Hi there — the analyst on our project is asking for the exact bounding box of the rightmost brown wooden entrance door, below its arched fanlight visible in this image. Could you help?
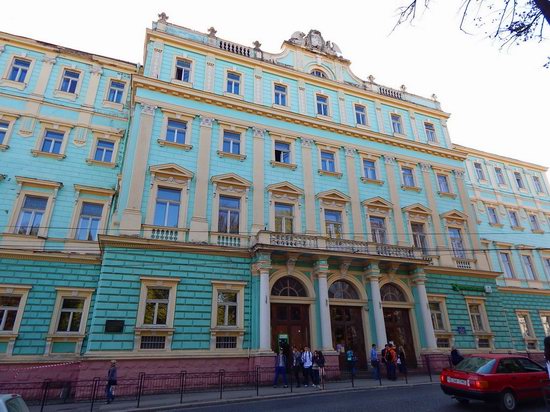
[384,308,416,368]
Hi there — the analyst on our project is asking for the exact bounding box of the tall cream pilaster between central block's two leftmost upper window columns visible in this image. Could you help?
[189,117,214,242]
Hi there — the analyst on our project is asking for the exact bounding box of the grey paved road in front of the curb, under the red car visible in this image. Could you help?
[174,385,546,412]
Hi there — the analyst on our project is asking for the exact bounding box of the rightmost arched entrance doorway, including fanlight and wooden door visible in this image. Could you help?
[380,283,416,368]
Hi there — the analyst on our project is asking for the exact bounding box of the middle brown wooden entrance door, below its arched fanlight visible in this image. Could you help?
[330,305,367,368]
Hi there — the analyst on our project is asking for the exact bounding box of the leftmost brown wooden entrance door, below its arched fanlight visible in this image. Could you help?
[271,303,310,351]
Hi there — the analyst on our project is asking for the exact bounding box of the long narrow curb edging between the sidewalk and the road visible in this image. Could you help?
[119,382,439,412]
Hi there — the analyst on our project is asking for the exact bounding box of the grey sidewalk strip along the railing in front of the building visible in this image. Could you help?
[30,375,439,412]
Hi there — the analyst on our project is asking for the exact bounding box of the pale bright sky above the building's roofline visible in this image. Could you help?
[0,0,550,174]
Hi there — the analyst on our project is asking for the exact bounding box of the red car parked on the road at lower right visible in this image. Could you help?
[440,354,548,411]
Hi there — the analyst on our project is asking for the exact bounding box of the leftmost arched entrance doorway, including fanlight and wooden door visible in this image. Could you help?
[271,276,311,351]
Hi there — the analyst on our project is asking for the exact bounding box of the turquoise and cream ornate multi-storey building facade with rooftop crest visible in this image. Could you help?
[0,15,550,377]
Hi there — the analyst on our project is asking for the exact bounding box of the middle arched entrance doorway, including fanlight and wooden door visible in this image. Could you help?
[328,279,367,369]
